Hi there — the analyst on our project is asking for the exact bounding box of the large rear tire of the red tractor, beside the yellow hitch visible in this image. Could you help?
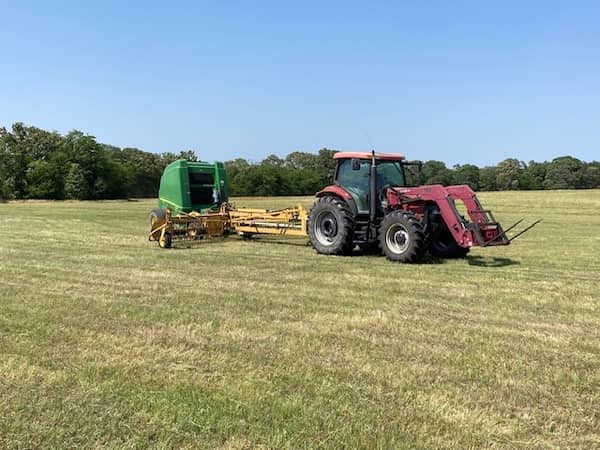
[308,196,354,255]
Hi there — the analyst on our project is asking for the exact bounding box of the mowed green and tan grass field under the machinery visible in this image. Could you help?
[0,190,600,449]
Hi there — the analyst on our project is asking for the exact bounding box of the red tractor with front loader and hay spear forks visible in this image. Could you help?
[308,151,537,262]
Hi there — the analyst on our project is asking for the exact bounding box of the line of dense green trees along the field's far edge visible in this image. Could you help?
[0,123,600,200]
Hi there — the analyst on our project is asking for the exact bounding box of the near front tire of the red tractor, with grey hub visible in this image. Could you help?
[379,210,425,263]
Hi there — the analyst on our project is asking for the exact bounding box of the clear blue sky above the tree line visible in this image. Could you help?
[0,0,600,166]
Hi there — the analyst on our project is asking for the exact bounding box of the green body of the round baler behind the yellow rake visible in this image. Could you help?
[158,159,228,215]
